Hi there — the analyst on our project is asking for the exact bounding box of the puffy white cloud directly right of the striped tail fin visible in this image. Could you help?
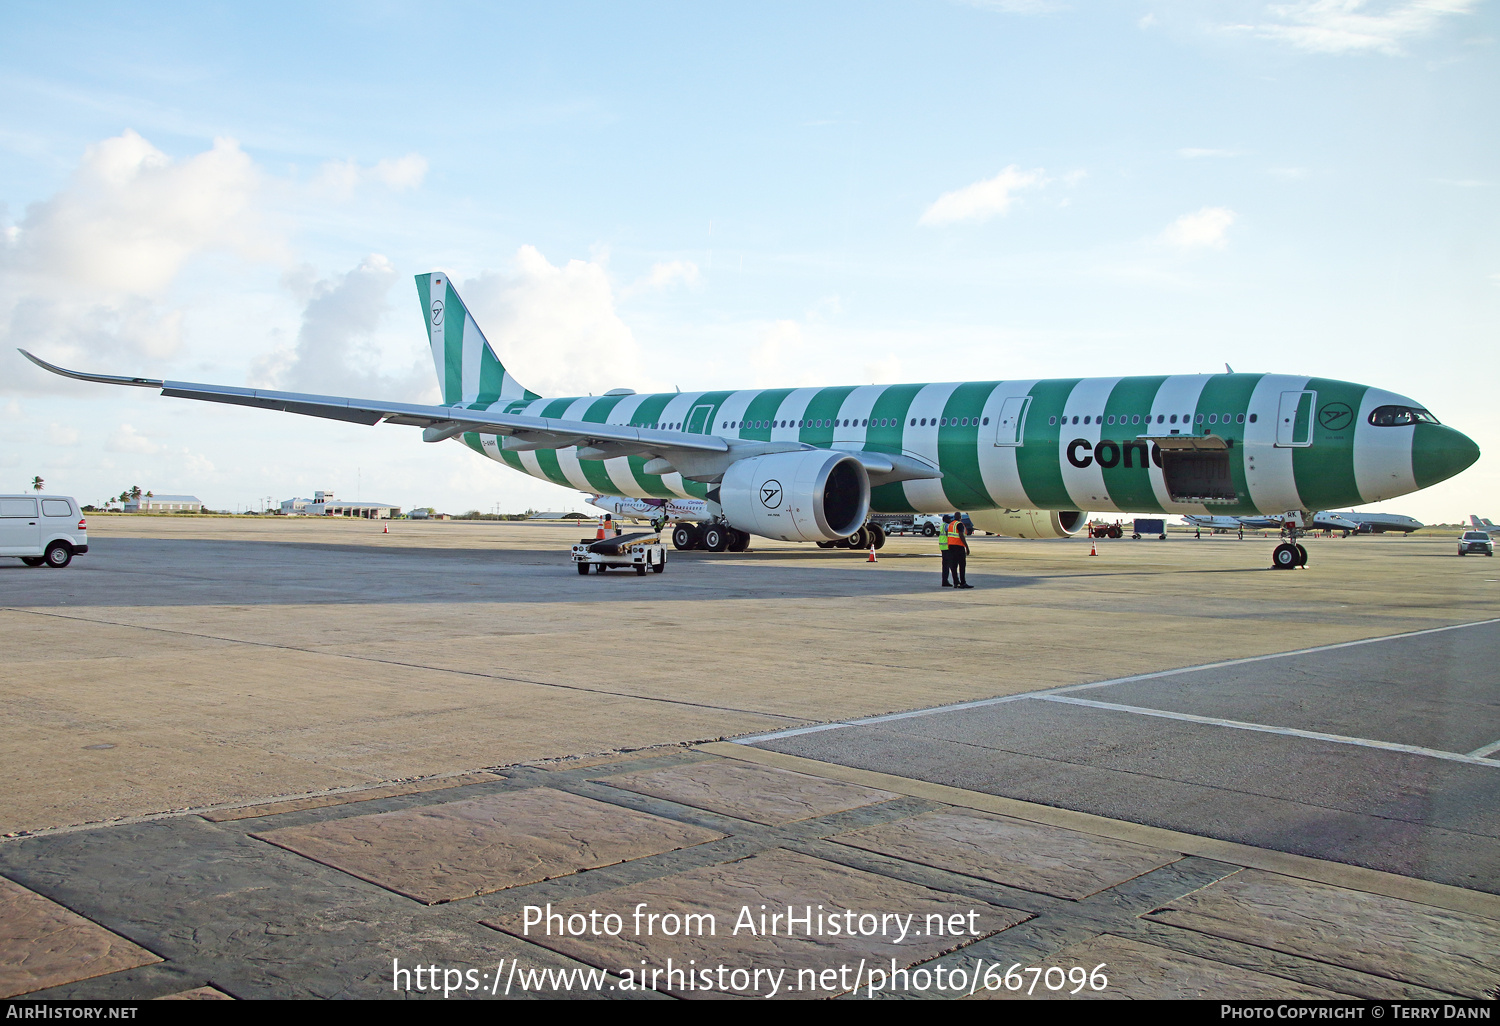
[459,246,657,396]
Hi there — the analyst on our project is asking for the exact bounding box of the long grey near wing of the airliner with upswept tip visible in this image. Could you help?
[20,350,729,459]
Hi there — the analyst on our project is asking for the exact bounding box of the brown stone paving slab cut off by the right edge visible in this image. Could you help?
[1146,870,1500,998]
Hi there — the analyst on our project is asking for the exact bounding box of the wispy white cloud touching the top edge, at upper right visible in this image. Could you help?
[1236,0,1478,54]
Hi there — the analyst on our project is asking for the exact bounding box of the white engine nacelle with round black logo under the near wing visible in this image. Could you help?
[719,449,870,542]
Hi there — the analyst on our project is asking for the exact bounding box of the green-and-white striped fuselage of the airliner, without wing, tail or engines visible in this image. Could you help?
[462,374,1452,515]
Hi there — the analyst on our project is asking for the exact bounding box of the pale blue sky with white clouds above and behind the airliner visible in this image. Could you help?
[0,0,1500,521]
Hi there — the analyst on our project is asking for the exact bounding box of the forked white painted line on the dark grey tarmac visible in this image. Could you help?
[732,617,1500,767]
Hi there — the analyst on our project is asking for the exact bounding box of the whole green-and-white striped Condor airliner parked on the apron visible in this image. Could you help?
[23,273,1479,569]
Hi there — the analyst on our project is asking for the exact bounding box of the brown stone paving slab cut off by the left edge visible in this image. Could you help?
[0,878,161,998]
